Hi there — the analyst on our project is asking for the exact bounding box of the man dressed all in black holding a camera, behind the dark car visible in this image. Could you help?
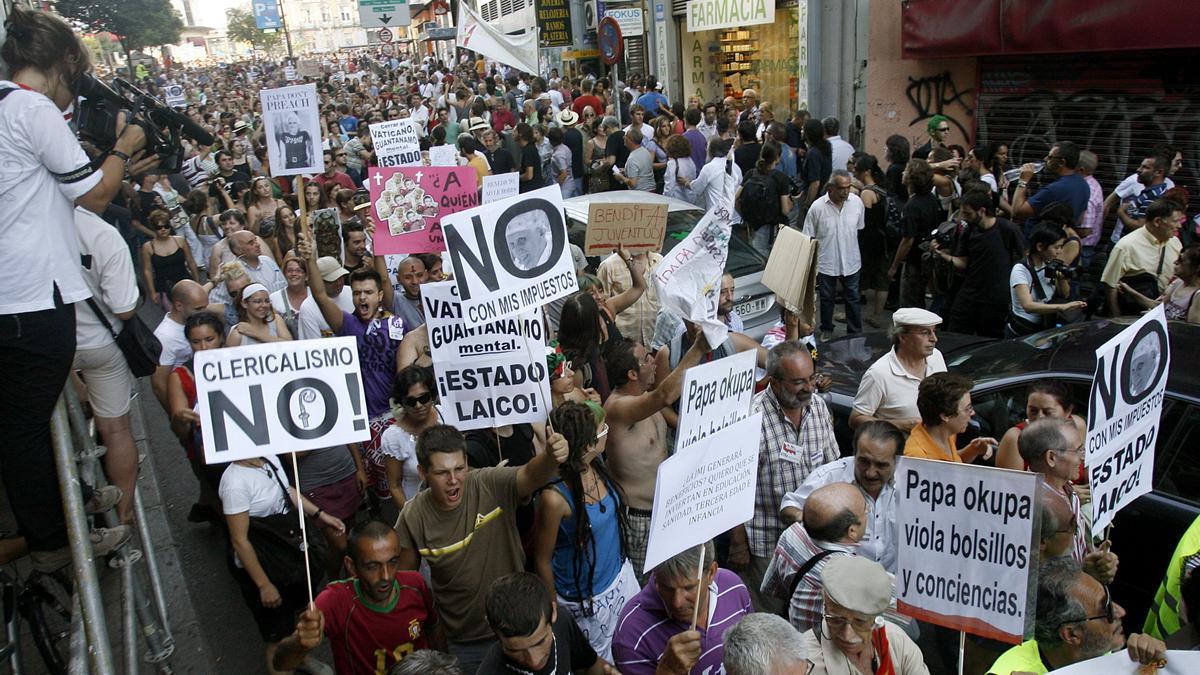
[929,190,1025,338]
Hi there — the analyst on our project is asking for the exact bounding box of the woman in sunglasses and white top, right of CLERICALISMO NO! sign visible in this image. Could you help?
[379,365,442,522]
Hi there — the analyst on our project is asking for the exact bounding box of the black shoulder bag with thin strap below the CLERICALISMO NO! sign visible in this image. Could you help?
[246,462,329,589]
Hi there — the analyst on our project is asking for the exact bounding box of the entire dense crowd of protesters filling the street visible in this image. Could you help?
[0,6,1200,675]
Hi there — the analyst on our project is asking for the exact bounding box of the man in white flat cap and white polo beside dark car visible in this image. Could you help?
[850,307,946,432]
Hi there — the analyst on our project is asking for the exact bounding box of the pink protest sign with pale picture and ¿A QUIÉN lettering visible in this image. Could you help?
[367,167,479,253]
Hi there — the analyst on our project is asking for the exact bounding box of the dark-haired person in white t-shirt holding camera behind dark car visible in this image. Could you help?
[1004,223,1087,338]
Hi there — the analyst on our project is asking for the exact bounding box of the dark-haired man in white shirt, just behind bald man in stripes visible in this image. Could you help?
[779,422,905,574]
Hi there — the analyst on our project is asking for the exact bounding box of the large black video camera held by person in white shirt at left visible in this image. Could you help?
[74,73,214,173]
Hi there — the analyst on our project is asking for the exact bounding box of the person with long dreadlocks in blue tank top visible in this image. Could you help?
[534,402,638,661]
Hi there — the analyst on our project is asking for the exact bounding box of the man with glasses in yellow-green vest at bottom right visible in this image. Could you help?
[988,556,1166,675]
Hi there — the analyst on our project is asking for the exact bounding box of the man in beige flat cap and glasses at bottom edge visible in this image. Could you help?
[800,556,929,675]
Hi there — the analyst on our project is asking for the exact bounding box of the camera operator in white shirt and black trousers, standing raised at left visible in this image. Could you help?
[0,6,158,571]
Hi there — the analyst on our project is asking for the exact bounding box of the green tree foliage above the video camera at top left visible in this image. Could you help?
[54,0,184,53]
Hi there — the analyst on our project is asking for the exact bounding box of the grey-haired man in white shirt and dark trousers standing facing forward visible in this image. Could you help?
[804,169,866,342]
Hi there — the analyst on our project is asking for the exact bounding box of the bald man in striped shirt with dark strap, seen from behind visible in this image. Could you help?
[762,483,866,633]
